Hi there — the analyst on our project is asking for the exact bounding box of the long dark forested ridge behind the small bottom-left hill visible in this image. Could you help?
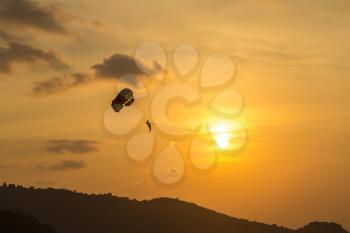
[0,185,348,233]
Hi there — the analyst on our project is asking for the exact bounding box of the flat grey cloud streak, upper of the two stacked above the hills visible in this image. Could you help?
[45,139,99,154]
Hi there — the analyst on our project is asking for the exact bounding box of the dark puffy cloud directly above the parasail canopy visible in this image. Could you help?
[91,54,162,85]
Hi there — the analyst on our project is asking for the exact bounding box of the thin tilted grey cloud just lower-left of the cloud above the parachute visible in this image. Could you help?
[32,73,91,96]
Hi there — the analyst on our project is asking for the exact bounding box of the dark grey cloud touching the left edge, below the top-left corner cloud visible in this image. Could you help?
[0,42,68,73]
